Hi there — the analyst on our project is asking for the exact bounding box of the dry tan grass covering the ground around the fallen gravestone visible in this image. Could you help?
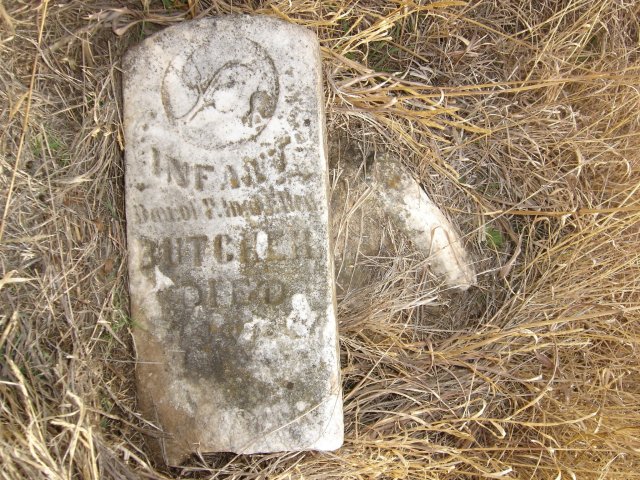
[0,0,640,479]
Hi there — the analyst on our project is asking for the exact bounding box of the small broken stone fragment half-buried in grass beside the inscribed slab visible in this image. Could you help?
[331,148,476,292]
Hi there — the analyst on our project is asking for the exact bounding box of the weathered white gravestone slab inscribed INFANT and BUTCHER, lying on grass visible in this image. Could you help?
[124,16,343,464]
